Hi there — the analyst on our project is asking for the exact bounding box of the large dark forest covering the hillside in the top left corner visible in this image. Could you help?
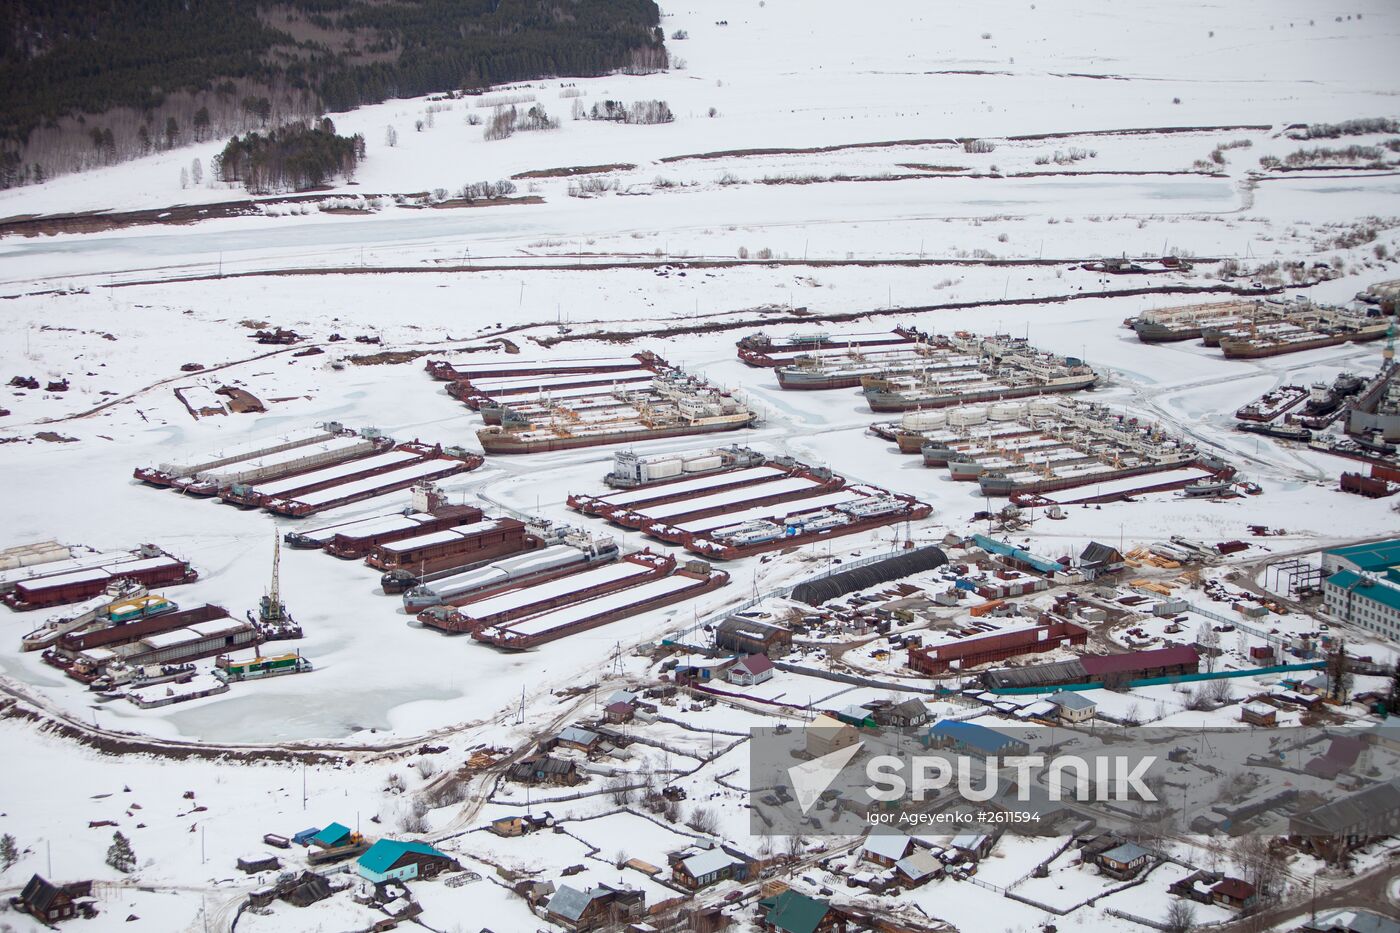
[0,0,665,186]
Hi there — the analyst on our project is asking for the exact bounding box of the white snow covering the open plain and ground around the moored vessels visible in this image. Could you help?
[0,0,1400,930]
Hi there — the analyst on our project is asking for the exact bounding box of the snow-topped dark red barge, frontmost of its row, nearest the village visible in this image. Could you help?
[472,562,729,651]
